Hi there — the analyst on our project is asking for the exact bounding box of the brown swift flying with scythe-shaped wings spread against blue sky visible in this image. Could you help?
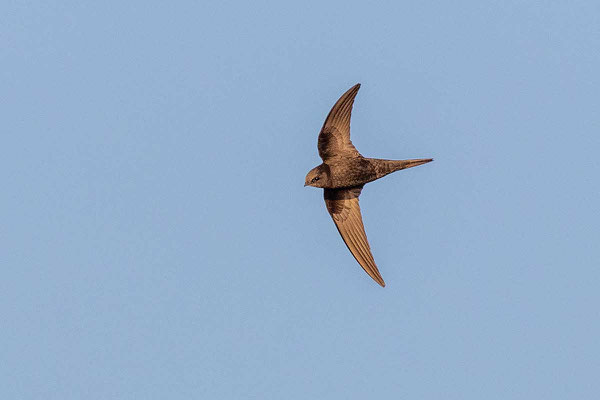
[304,83,433,286]
